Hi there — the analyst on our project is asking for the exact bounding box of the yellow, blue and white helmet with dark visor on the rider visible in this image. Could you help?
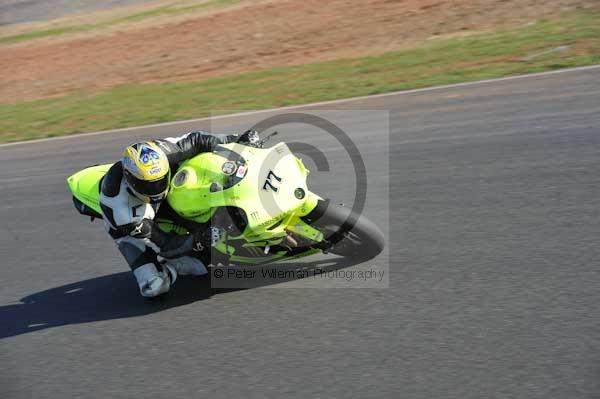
[121,141,171,203]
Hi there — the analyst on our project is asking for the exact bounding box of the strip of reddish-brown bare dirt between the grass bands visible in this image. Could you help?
[0,0,598,103]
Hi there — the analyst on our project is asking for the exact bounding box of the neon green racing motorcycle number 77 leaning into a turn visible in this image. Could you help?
[67,133,385,265]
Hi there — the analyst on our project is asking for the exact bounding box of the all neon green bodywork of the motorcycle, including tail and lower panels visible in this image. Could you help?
[67,143,323,264]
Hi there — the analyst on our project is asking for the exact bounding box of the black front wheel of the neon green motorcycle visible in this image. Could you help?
[302,200,385,260]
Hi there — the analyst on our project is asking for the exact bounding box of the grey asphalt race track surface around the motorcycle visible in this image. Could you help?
[0,69,600,398]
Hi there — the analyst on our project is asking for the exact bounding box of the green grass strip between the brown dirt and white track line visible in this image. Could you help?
[0,10,600,142]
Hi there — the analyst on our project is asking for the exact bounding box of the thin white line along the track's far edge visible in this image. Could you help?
[0,65,600,148]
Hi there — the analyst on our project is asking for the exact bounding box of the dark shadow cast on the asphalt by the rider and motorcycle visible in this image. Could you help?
[0,258,357,339]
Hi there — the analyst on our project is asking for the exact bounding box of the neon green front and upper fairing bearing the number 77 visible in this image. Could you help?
[167,143,316,241]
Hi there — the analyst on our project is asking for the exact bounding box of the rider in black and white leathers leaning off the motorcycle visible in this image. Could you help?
[100,130,258,298]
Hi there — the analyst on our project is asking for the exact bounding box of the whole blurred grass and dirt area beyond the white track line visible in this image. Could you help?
[0,0,600,142]
